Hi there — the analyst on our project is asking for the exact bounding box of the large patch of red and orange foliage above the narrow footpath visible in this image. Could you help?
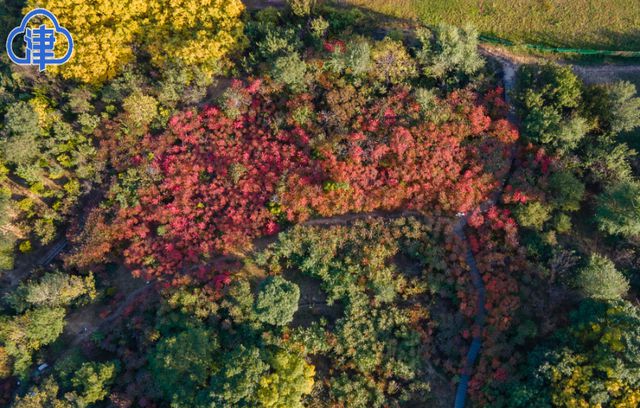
[75,82,518,284]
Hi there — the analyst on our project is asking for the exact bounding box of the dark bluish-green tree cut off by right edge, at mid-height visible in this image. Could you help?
[595,181,640,237]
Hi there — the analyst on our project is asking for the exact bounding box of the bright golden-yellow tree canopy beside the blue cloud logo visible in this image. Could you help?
[25,0,244,84]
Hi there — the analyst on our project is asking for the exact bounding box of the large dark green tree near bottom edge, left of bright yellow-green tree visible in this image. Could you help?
[149,328,218,407]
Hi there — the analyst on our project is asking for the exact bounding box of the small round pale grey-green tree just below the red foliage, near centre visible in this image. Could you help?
[255,276,300,326]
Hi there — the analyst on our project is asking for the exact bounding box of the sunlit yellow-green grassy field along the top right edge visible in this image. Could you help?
[341,0,640,51]
